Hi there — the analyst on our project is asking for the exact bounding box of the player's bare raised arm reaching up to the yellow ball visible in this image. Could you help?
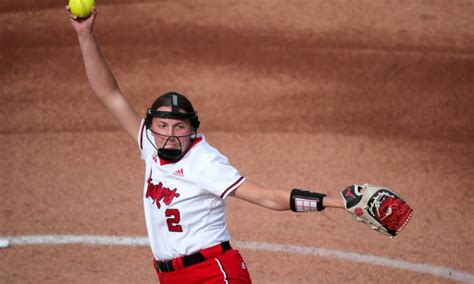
[66,7,141,139]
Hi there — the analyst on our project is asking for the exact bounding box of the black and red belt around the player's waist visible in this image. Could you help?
[153,241,232,272]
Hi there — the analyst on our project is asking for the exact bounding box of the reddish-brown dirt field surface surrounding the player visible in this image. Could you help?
[0,0,474,283]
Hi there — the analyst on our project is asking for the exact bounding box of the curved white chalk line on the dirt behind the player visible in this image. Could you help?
[0,235,474,283]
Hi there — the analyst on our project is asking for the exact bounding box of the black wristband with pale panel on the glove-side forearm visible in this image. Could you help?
[290,188,326,212]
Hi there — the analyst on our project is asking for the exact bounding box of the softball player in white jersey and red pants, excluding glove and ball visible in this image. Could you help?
[70,9,345,283]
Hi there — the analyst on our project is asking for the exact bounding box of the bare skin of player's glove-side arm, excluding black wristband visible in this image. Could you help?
[231,180,345,211]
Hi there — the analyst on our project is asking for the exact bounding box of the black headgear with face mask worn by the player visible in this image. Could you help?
[145,92,200,162]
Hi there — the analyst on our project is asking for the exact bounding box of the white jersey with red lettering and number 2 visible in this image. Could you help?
[138,118,245,260]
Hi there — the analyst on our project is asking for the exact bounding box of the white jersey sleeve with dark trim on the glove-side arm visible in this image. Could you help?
[199,153,245,199]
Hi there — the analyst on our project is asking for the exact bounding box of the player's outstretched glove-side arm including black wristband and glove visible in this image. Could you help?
[231,180,413,237]
